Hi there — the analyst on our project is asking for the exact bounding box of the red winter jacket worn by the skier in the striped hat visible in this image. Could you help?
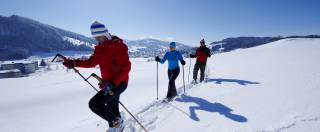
[77,37,131,86]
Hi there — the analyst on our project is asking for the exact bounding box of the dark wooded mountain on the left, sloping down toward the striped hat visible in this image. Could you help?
[0,15,95,60]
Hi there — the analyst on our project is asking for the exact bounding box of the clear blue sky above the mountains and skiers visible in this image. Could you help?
[0,0,320,45]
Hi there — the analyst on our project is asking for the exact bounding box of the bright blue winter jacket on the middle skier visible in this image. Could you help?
[160,50,183,70]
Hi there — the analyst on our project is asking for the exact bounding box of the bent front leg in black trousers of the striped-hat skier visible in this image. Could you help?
[89,90,116,126]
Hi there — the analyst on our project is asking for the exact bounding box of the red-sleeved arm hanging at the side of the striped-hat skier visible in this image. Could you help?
[113,44,131,86]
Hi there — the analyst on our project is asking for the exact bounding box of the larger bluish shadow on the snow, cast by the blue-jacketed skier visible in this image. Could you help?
[175,94,248,122]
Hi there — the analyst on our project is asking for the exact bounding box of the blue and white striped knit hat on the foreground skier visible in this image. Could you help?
[90,21,112,40]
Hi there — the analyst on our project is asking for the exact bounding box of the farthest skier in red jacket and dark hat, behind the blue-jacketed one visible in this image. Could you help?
[190,39,211,83]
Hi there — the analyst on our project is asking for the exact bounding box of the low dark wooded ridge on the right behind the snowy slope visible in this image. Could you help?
[209,35,320,52]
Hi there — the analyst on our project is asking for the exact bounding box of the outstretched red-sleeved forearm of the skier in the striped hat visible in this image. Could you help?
[75,49,100,68]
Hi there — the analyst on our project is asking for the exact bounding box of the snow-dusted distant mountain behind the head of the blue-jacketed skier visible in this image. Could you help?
[126,39,191,57]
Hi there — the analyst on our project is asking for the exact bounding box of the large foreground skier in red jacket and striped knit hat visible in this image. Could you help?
[64,22,131,132]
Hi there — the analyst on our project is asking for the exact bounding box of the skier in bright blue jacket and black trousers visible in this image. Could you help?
[155,42,186,101]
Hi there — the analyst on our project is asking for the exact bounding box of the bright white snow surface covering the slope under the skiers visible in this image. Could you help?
[0,39,320,132]
